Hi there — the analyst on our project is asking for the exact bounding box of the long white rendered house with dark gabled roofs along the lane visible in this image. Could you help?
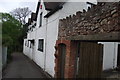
[23,0,92,76]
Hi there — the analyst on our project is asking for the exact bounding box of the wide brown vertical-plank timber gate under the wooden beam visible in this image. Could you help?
[78,42,103,78]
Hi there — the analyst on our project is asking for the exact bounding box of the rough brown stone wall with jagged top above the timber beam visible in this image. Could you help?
[58,2,120,40]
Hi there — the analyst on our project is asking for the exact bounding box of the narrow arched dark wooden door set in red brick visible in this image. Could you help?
[58,44,66,78]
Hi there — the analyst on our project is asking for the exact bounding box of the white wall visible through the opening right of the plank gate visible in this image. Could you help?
[100,42,119,70]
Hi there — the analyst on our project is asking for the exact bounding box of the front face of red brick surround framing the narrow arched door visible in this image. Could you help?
[54,40,71,78]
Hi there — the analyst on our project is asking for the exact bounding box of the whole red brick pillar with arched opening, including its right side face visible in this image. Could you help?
[55,40,76,78]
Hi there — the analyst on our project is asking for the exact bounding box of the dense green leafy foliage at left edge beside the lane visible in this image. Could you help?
[0,13,23,53]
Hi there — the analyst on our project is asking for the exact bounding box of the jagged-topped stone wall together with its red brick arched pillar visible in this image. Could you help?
[55,2,120,78]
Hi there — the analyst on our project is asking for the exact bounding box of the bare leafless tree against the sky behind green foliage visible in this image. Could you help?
[10,7,31,24]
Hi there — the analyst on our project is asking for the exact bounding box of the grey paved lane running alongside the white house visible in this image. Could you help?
[3,53,46,78]
